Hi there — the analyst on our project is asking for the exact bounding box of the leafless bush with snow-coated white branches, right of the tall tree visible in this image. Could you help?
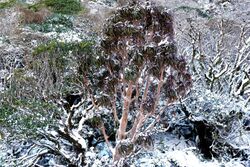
[177,9,250,99]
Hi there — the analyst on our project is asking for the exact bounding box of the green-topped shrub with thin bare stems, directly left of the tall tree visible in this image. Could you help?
[29,41,94,96]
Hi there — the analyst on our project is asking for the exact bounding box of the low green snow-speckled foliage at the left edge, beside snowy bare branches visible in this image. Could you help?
[0,98,59,138]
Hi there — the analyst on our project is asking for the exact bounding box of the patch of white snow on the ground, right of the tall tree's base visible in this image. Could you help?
[133,133,248,167]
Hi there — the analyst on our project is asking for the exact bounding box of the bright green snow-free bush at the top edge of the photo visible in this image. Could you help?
[44,0,82,15]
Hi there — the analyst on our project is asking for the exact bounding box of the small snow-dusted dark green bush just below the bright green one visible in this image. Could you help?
[29,14,73,33]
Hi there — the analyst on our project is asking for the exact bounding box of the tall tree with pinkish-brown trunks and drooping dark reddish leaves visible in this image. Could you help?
[92,2,191,161]
